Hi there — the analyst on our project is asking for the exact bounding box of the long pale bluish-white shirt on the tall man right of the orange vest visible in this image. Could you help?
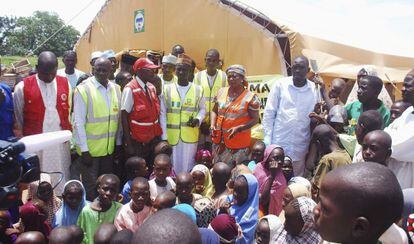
[262,76,318,161]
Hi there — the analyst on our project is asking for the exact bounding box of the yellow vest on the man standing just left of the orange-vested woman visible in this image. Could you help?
[194,69,228,120]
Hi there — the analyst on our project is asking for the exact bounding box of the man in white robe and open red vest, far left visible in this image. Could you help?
[13,52,72,195]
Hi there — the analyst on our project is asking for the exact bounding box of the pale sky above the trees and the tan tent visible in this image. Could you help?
[0,0,414,57]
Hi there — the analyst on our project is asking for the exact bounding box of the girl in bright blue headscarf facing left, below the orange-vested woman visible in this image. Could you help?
[227,174,259,243]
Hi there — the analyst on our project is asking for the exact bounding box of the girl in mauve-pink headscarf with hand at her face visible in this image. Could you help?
[254,145,286,215]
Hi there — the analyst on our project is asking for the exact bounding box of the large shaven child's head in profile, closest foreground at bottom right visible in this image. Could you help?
[314,162,403,244]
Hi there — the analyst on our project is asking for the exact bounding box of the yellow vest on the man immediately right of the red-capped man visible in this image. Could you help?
[164,83,203,146]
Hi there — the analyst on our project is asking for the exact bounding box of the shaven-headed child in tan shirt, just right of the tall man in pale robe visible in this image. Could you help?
[312,124,352,188]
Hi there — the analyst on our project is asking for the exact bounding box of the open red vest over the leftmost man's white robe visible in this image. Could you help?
[23,75,72,136]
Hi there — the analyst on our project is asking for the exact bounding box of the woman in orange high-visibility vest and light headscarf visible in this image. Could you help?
[210,64,260,168]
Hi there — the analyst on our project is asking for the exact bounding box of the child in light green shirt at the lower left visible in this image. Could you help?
[77,174,122,244]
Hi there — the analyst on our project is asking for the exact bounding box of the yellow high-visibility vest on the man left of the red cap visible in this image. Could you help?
[75,77,121,157]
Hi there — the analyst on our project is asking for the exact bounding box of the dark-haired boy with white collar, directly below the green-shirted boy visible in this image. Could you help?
[352,110,383,163]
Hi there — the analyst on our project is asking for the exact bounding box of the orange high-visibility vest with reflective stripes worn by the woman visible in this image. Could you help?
[212,87,254,149]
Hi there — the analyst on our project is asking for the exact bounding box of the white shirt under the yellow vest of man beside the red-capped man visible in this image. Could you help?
[160,83,206,140]
